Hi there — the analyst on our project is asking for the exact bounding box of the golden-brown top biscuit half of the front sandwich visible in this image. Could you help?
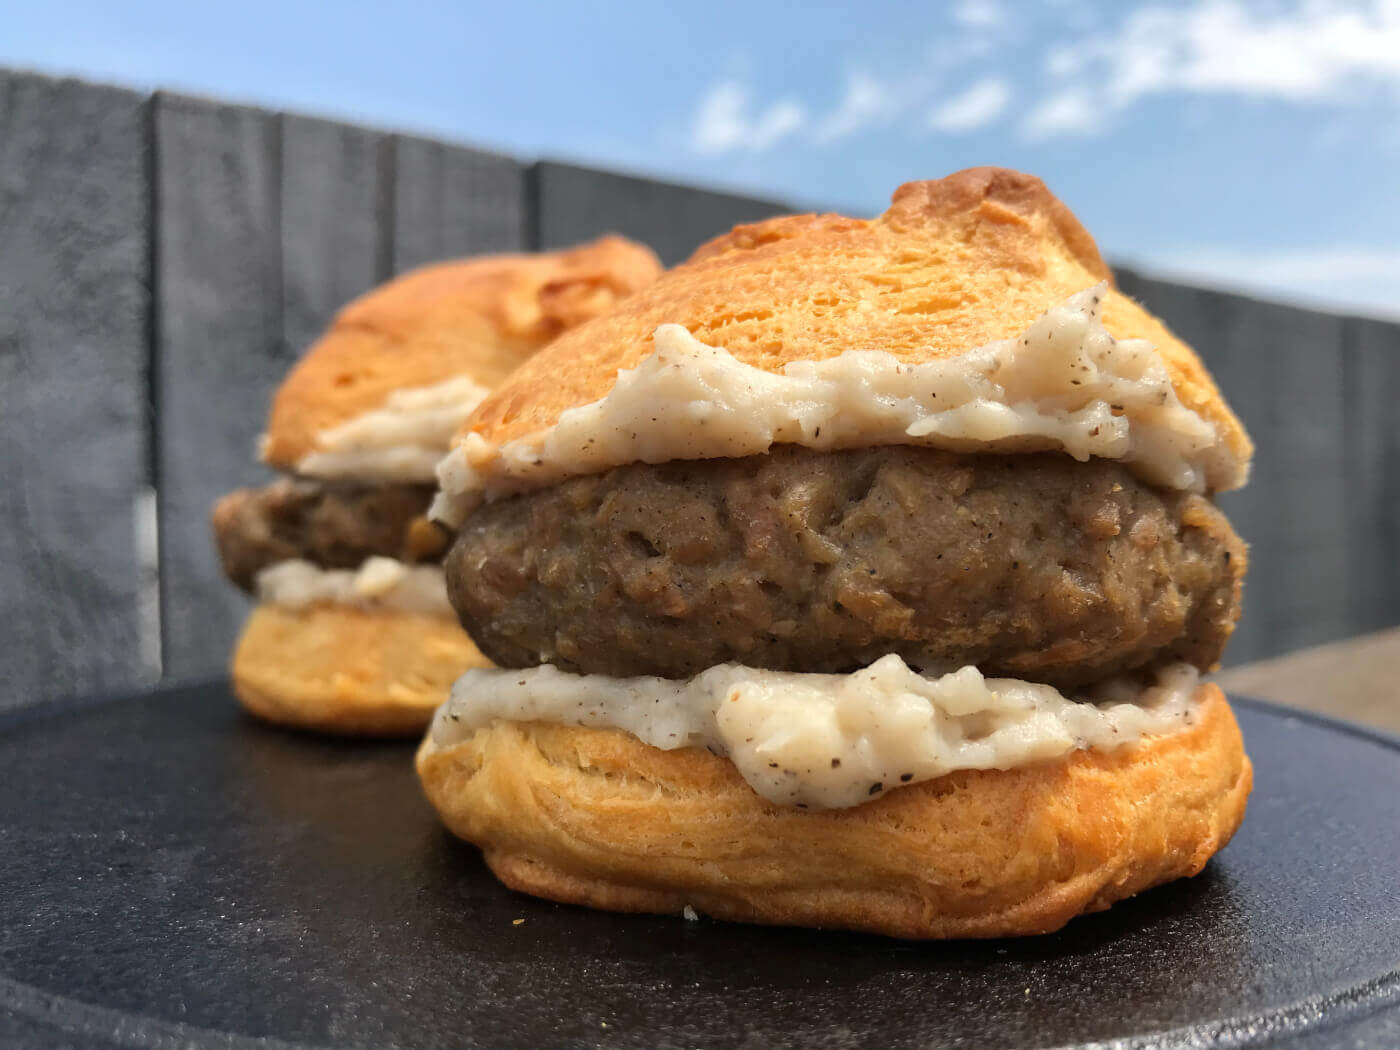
[469,168,1253,462]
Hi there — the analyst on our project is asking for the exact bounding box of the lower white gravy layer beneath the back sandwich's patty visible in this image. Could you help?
[256,557,456,619]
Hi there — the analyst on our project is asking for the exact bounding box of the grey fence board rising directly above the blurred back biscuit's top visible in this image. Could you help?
[391,136,526,273]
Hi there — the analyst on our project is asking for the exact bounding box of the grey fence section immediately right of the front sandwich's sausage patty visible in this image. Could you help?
[1119,272,1349,664]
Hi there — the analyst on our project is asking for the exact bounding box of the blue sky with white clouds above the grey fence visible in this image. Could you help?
[0,0,1400,316]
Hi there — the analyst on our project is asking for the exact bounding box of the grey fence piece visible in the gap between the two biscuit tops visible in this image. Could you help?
[531,161,792,266]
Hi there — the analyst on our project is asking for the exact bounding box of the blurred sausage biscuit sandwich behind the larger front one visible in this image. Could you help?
[213,237,661,735]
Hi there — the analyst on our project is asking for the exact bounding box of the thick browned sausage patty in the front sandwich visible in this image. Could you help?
[447,447,1245,686]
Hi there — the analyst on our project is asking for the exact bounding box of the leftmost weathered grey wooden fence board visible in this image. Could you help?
[0,70,151,710]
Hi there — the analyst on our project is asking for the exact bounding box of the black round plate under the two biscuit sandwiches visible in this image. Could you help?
[0,683,1400,1047]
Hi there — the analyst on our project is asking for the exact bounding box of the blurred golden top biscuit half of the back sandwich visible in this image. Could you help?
[263,237,661,469]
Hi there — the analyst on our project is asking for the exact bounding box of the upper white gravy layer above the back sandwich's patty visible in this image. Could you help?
[297,375,490,482]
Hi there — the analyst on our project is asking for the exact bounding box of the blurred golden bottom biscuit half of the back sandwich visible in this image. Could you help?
[232,602,490,736]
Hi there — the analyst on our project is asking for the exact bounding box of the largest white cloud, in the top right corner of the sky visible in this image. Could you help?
[1022,0,1400,139]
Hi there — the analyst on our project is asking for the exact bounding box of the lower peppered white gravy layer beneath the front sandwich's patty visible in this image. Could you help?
[430,654,1198,809]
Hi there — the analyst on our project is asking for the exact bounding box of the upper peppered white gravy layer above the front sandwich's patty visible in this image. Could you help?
[431,284,1246,526]
